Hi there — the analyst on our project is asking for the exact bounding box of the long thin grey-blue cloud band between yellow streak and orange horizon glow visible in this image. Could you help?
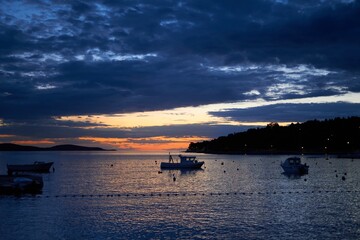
[1,121,247,140]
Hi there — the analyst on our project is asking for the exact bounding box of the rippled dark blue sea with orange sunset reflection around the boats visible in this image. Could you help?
[0,152,360,240]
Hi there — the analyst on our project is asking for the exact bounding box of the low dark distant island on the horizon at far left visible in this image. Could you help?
[0,143,113,151]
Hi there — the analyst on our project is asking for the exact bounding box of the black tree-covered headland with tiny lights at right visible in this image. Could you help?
[186,117,360,156]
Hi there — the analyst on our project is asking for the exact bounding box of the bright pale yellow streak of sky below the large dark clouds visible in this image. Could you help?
[57,92,360,130]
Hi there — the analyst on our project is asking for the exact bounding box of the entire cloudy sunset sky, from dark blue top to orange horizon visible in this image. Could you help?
[0,0,360,152]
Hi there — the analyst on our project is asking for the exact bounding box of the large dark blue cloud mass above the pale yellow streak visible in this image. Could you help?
[0,0,360,140]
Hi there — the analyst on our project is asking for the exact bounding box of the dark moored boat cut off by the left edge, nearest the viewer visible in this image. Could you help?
[0,175,43,194]
